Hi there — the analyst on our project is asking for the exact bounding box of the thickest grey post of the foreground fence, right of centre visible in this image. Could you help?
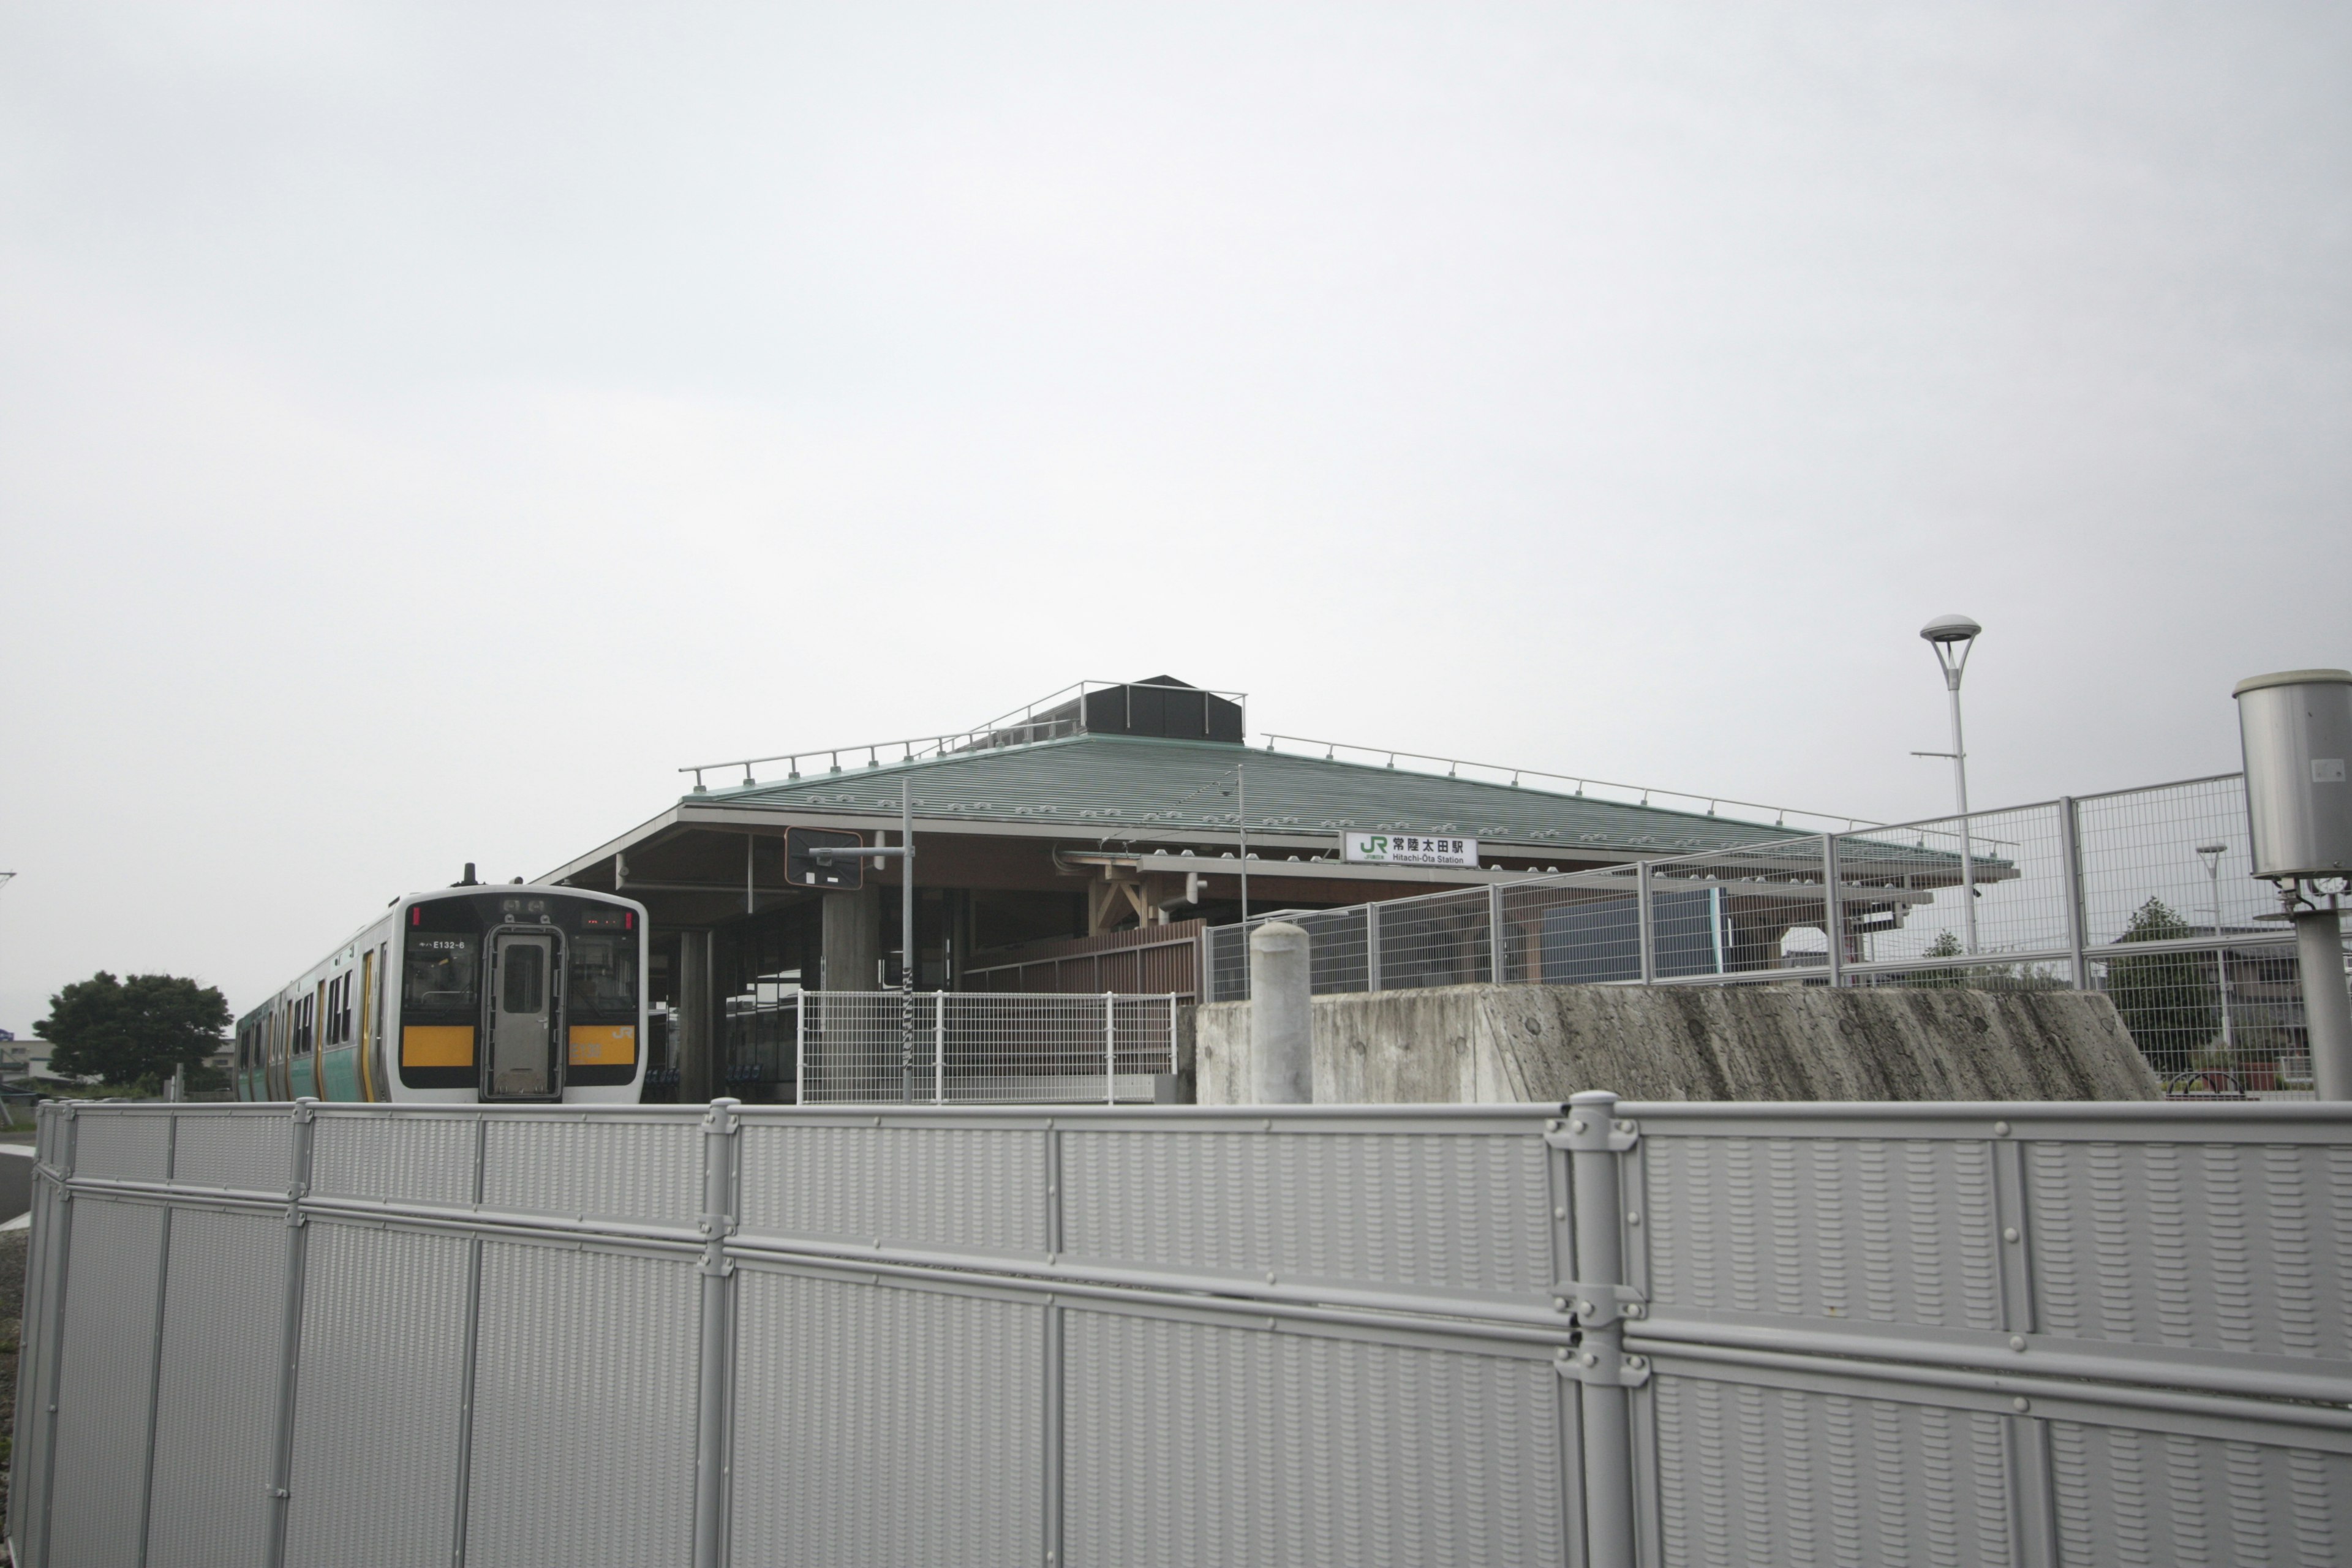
[1566,1090,1649,1568]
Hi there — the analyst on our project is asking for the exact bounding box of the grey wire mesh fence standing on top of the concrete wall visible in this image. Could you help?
[1207,774,2345,1096]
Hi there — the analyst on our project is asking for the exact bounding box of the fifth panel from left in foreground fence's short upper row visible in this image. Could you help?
[736,1107,1051,1260]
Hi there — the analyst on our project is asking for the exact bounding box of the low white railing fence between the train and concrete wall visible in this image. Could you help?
[727,992,1178,1105]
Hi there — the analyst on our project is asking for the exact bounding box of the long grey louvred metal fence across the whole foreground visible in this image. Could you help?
[9,1096,2352,1568]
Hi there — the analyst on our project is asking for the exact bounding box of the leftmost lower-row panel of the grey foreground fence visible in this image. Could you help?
[47,1194,165,1568]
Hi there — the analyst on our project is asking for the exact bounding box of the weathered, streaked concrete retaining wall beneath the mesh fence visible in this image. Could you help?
[1193,985,2159,1105]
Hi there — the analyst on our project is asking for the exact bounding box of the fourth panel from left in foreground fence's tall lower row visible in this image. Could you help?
[466,1242,698,1568]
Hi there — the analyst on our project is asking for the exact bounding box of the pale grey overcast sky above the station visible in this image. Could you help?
[0,0,2352,1032]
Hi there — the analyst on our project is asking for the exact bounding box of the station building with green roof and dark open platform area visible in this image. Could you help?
[541,675,1882,1098]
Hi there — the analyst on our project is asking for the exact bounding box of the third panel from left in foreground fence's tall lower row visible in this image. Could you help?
[279,1222,475,1568]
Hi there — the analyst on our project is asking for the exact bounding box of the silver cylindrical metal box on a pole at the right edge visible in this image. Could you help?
[2232,670,2352,881]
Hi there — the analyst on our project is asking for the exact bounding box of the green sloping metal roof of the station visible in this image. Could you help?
[687,733,1957,870]
